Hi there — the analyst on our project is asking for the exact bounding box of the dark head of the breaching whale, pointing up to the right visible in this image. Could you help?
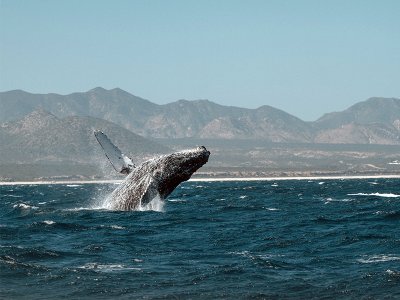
[157,146,210,198]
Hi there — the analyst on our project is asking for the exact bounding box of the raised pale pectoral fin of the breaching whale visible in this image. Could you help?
[94,130,135,174]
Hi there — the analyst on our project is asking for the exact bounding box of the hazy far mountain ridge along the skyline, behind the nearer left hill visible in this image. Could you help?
[0,88,400,144]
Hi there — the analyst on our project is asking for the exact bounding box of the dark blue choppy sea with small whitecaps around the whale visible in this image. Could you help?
[0,179,400,299]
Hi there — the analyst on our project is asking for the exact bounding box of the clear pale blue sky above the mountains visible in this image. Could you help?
[0,0,400,120]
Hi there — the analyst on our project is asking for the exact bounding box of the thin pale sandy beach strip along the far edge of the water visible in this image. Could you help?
[0,174,400,186]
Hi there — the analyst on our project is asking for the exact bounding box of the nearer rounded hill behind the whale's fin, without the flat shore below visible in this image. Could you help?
[0,109,171,164]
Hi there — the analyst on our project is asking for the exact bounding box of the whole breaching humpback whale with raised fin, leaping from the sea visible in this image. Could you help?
[95,131,210,210]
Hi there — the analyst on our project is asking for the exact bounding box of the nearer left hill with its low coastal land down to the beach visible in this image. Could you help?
[0,109,172,180]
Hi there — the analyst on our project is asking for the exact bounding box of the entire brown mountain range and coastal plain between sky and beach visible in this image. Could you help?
[0,88,400,181]
